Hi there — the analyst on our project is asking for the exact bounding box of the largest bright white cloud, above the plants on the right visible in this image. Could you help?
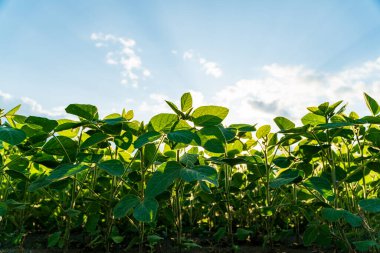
[212,58,380,124]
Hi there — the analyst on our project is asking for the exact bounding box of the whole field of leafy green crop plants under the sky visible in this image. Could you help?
[0,93,380,252]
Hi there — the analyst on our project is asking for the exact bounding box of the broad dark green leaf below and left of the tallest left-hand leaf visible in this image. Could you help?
[42,136,78,161]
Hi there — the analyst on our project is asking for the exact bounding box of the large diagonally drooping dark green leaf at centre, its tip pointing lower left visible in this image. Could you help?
[145,161,182,198]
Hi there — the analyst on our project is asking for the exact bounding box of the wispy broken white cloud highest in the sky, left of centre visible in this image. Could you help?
[91,33,151,87]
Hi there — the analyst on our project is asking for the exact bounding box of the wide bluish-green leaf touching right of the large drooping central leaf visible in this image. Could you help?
[180,165,218,186]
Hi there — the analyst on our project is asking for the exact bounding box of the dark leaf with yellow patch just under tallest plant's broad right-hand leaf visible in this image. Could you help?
[197,126,225,153]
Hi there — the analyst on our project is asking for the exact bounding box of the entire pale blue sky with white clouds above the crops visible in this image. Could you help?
[0,0,380,123]
